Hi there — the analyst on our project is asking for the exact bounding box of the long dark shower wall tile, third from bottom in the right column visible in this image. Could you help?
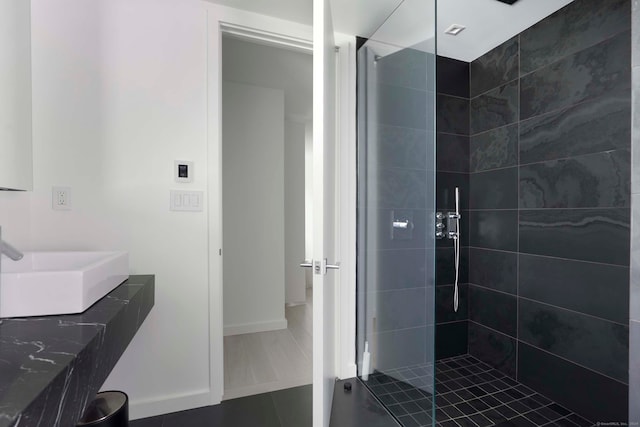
[516,252,629,323]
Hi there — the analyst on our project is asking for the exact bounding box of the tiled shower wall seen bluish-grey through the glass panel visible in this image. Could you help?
[358,49,436,371]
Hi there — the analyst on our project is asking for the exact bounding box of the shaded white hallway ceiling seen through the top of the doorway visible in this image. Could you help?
[222,36,313,123]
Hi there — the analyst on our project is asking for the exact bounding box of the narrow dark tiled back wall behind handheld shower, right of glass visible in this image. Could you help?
[436,56,470,359]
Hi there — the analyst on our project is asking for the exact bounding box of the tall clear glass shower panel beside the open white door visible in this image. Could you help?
[357,0,436,426]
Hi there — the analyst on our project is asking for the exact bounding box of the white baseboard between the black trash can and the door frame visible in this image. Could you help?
[129,390,211,420]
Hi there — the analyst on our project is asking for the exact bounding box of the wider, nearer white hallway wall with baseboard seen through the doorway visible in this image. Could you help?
[222,82,287,335]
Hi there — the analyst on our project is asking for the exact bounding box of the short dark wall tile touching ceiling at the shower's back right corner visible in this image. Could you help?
[470,37,519,97]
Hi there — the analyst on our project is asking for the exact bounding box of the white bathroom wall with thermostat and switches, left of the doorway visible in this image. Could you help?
[30,0,210,418]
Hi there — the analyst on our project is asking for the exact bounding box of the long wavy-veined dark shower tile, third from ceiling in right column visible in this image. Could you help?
[520,93,631,166]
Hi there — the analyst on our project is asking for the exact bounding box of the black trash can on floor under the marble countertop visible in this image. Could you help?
[76,391,129,427]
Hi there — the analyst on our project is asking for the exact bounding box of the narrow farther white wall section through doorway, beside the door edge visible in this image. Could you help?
[284,120,307,303]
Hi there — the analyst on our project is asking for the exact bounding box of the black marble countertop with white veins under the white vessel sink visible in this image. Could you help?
[0,276,155,427]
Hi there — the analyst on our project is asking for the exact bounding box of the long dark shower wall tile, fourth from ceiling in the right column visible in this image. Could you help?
[520,150,631,209]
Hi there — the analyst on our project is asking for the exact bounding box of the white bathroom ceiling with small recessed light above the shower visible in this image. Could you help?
[208,0,573,61]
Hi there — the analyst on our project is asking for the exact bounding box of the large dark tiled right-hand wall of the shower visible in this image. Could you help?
[462,0,640,422]
